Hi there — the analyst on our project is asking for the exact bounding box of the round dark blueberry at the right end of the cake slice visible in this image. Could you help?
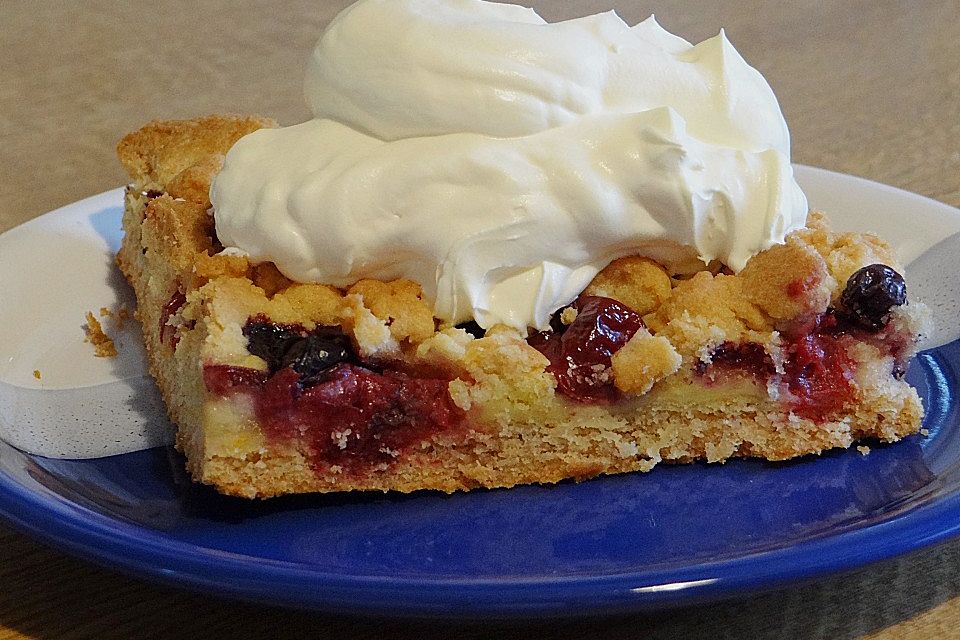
[840,264,907,331]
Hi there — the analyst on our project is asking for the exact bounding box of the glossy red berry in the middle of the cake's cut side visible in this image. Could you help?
[528,296,644,402]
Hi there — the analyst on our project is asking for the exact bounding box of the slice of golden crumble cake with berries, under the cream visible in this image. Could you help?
[118,116,924,497]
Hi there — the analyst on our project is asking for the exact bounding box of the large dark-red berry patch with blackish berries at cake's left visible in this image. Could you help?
[203,318,464,473]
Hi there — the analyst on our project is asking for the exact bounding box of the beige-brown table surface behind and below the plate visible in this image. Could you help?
[0,0,960,640]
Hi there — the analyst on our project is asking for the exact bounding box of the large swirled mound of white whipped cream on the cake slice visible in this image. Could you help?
[211,0,807,329]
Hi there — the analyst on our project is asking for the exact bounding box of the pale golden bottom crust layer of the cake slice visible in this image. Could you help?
[191,389,922,498]
